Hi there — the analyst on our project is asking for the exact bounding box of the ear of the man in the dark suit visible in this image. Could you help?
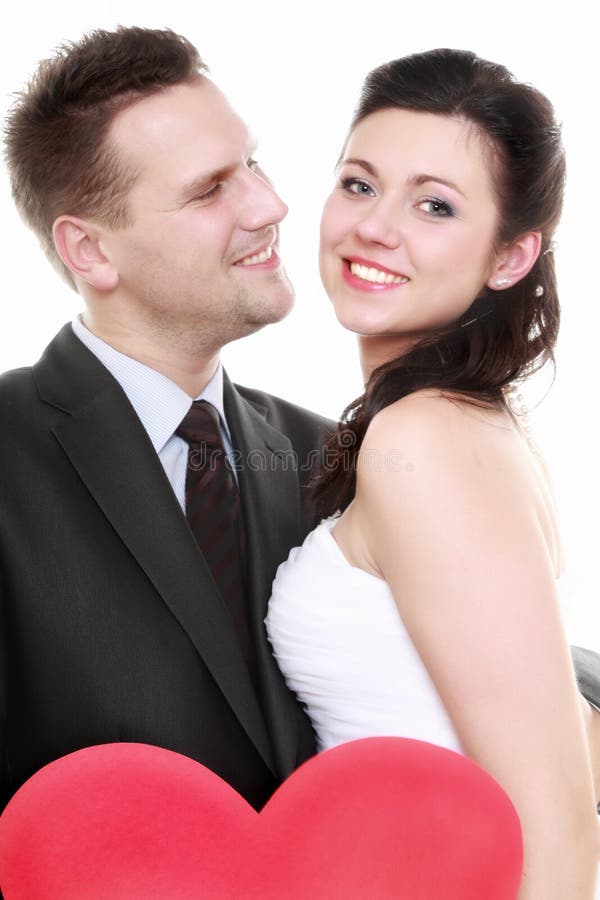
[52,216,119,291]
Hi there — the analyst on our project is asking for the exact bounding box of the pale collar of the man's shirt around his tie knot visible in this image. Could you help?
[71,317,231,453]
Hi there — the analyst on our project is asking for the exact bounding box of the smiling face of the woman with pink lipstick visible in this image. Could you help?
[320,109,498,355]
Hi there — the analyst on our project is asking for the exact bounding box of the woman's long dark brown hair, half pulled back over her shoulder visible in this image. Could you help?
[315,50,565,513]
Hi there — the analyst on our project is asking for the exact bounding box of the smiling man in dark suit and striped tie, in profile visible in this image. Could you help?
[0,28,590,807]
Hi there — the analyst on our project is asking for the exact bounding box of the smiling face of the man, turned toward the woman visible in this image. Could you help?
[98,77,293,350]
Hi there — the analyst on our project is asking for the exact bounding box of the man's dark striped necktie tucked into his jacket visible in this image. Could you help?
[175,400,256,683]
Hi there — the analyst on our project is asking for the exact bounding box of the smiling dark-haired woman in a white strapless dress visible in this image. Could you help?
[267,50,598,900]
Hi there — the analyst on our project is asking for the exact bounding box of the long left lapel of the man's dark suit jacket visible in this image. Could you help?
[35,326,274,770]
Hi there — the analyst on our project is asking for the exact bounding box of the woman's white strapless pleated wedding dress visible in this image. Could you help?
[266,517,462,752]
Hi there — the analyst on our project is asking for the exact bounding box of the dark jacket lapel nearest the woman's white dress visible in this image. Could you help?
[224,376,301,777]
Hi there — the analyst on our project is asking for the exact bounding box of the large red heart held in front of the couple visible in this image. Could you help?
[0,738,522,900]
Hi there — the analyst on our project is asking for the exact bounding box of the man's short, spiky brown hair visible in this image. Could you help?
[5,27,206,286]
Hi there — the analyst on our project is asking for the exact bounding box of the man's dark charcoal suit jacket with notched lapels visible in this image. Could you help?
[0,326,331,807]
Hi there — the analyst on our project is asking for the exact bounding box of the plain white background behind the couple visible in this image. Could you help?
[0,0,600,649]
